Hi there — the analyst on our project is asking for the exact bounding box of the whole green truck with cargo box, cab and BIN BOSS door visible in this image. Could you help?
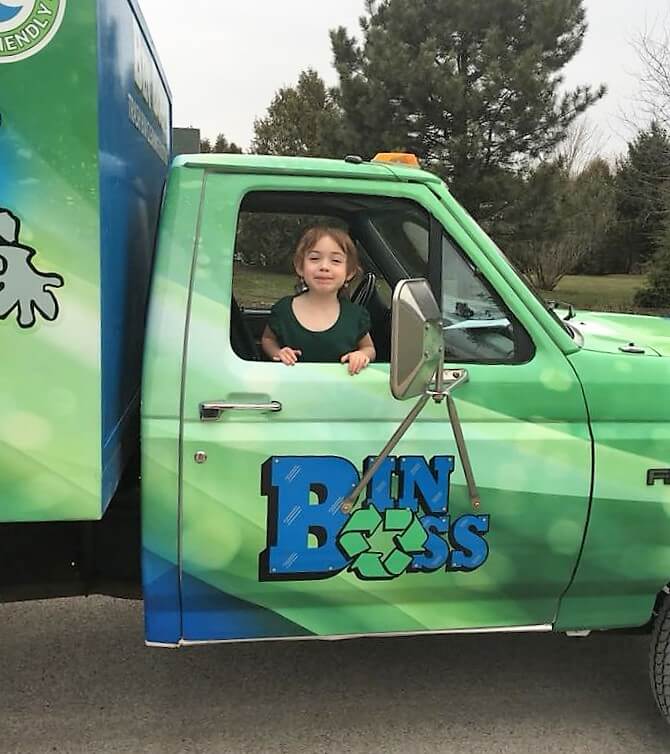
[0,0,670,719]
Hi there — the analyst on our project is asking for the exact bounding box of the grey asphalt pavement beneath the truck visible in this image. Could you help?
[0,597,670,754]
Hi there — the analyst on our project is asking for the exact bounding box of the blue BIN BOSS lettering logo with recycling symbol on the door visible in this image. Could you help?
[259,456,490,581]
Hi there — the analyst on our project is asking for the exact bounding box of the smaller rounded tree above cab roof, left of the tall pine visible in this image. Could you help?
[251,69,340,157]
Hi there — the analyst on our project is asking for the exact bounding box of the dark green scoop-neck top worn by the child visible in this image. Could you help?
[268,296,370,363]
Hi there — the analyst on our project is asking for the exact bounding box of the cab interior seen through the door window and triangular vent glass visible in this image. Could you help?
[230,191,534,364]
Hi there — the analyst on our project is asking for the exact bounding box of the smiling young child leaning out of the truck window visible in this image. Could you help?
[261,227,375,375]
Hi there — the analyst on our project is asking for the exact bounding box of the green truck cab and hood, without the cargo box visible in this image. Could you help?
[141,155,670,645]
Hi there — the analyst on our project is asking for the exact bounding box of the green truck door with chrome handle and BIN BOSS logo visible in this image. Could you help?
[180,172,591,642]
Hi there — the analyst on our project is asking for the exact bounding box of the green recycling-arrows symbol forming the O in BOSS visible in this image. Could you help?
[337,506,428,579]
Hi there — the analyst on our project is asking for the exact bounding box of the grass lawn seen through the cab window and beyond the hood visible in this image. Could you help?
[234,265,651,313]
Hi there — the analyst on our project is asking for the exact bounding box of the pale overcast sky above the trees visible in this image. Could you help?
[139,0,670,154]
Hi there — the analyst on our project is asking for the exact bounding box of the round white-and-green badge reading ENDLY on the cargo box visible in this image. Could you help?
[0,0,66,63]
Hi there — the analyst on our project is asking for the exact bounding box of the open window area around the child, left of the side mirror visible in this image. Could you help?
[230,191,430,362]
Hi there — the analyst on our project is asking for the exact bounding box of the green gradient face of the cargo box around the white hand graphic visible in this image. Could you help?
[0,0,101,521]
